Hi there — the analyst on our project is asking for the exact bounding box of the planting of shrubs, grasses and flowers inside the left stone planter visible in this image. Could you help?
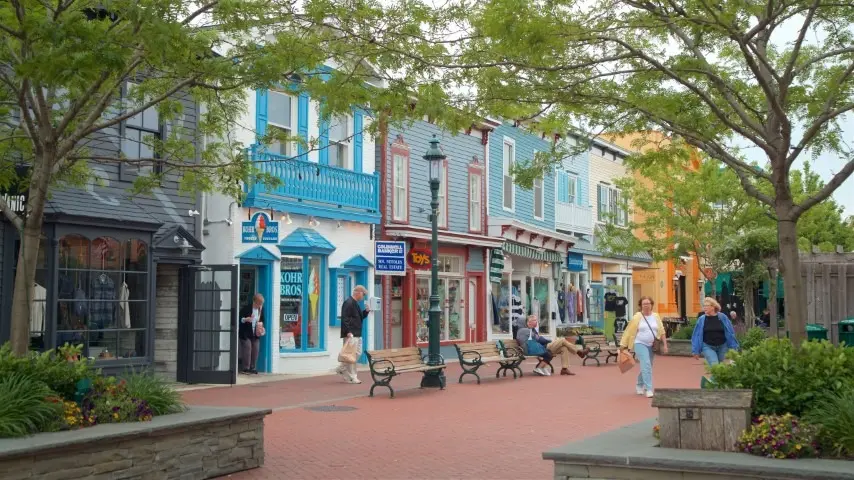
[0,345,184,438]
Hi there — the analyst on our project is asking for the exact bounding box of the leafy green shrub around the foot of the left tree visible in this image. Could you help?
[0,343,98,400]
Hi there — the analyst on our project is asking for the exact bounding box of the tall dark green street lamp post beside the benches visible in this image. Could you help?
[421,135,447,388]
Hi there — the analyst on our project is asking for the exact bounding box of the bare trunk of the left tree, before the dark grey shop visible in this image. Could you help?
[9,158,52,355]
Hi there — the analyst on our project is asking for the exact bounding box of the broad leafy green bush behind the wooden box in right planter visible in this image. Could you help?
[711,338,854,416]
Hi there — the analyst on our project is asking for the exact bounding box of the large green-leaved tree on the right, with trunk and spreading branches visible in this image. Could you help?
[434,0,854,343]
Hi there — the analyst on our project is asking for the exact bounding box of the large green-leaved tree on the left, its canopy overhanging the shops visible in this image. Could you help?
[0,0,454,354]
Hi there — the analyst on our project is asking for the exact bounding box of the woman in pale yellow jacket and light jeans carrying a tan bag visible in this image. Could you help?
[620,296,667,398]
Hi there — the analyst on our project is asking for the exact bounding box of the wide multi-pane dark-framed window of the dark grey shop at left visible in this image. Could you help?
[56,235,149,360]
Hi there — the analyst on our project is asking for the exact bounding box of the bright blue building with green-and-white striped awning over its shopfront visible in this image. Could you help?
[487,123,575,339]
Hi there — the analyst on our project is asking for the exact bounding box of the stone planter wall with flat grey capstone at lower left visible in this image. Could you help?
[0,407,271,480]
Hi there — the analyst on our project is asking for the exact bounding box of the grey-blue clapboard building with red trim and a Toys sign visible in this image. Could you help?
[376,120,501,359]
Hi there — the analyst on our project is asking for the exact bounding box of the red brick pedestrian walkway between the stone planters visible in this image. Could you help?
[184,357,703,480]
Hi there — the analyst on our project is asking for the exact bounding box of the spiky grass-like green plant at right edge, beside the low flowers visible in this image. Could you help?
[805,389,854,457]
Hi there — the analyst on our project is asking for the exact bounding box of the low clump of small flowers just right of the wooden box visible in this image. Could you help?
[736,414,818,458]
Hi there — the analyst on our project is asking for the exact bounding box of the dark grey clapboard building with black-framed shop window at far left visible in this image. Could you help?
[0,83,207,379]
